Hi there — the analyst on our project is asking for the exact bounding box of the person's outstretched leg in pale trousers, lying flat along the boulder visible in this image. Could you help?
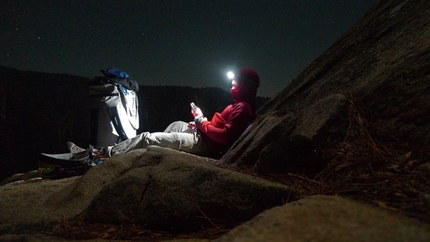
[109,132,201,157]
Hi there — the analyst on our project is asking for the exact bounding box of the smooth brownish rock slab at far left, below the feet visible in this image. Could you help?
[0,150,139,233]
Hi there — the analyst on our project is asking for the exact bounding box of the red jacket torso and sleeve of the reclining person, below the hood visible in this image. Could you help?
[199,102,255,145]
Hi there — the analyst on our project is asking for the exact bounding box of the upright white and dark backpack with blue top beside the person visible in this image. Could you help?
[89,68,139,147]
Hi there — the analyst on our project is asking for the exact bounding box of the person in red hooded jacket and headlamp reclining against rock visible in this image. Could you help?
[72,68,260,158]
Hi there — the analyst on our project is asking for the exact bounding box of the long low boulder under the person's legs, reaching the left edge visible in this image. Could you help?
[0,146,297,231]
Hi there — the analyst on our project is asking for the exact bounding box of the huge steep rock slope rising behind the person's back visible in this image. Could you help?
[222,0,430,169]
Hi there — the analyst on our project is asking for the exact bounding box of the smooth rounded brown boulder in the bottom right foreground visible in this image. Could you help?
[214,195,430,242]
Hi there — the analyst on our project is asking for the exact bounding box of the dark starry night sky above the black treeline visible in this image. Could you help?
[0,0,377,97]
